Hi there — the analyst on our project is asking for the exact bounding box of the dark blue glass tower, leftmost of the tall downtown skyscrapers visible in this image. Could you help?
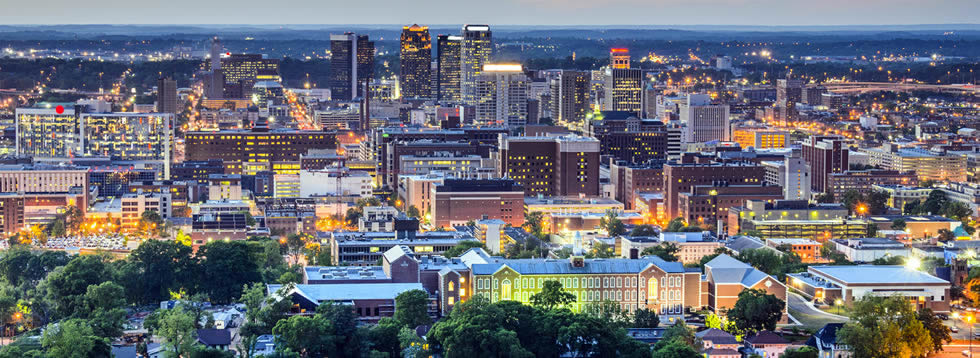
[330,32,374,101]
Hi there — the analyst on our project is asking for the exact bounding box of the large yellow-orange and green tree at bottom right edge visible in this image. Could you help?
[837,295,934,358]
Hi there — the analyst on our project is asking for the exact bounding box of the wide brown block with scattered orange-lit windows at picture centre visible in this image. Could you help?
[500,135,599,196]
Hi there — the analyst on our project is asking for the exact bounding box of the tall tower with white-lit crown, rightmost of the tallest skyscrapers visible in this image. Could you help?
[459,25,493,105]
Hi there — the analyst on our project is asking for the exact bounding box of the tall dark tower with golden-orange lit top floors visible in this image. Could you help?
[398,24,432,98]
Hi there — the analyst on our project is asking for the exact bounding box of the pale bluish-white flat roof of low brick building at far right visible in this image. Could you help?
[810,265,949,285]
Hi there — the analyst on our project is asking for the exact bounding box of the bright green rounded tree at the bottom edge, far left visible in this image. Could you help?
[41,319,110,358]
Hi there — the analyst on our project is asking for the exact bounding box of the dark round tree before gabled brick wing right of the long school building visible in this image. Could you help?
[727,289,786,333]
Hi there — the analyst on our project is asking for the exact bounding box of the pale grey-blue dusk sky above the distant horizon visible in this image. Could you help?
[0,0,980,25]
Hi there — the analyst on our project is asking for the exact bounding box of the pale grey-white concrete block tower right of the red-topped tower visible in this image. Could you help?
[679,94,730,143]
